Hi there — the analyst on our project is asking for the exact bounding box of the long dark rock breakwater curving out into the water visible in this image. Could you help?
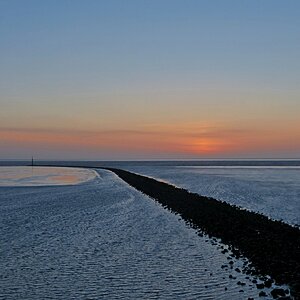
[106,168,300,299]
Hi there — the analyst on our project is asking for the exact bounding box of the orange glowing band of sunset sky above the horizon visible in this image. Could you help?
[0,119,300,157]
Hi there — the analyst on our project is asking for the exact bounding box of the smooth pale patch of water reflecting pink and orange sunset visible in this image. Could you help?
[0,167,96,186]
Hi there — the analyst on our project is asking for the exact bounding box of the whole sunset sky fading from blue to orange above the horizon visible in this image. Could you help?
[0,0,300,160]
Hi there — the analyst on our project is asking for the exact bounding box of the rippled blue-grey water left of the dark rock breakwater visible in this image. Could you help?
[0,170,282,299]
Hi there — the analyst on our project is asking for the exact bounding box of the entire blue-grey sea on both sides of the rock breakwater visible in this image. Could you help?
[0,160,300,299]
